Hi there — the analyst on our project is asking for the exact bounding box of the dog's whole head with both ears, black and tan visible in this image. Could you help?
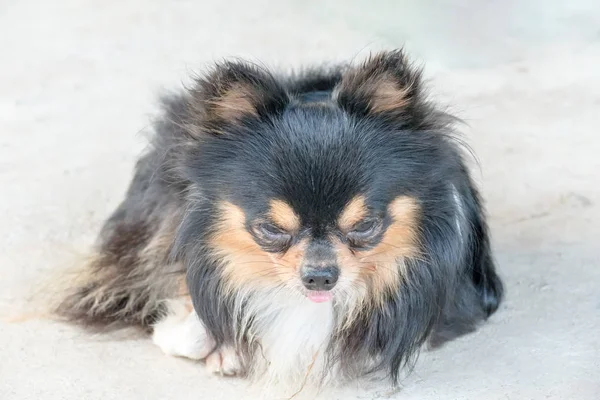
[178,53,457,302]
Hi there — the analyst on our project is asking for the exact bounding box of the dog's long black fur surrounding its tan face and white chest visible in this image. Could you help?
[58,51,502,381]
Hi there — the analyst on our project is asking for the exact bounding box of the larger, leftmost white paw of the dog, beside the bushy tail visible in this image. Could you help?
[152,300,215,360]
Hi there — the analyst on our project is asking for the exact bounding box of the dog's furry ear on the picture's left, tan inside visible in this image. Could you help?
[189,62,289,132]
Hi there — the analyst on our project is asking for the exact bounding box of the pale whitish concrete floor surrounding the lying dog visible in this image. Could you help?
[0,0,600,400]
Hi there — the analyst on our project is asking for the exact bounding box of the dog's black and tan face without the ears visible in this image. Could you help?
[210,114,419,301]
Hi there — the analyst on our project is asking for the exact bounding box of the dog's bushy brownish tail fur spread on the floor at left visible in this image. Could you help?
[51,202,185,330]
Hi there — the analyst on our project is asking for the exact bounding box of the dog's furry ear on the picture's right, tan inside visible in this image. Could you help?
[336,50,427,125]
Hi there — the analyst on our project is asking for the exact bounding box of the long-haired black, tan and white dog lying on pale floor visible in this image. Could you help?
[55,50,503,385]
